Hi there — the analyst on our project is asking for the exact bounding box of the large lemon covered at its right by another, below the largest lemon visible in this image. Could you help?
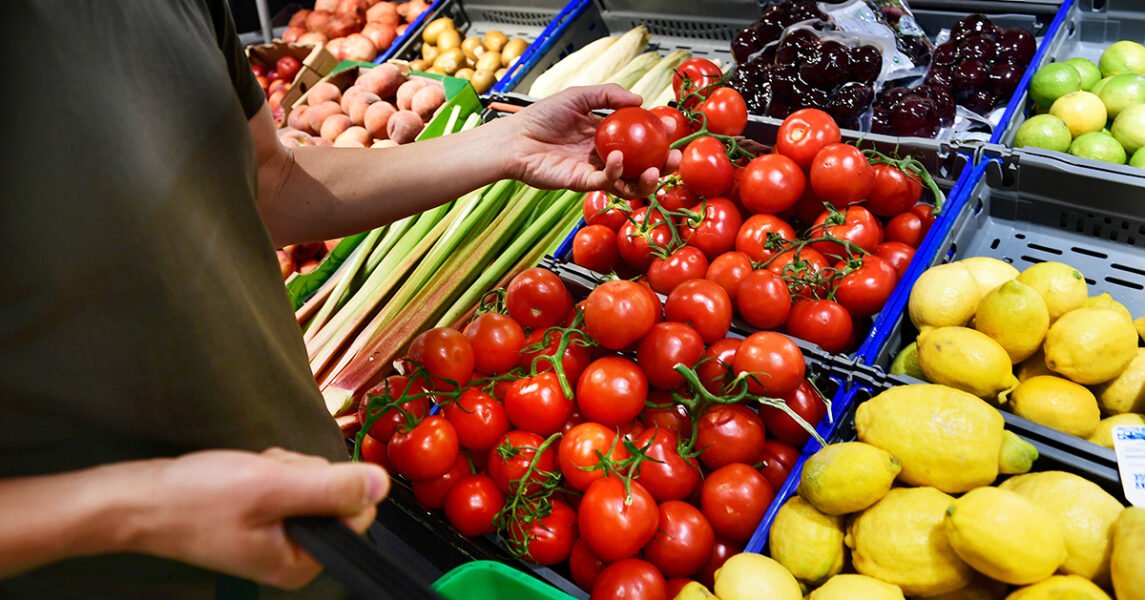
[847,488,973,598]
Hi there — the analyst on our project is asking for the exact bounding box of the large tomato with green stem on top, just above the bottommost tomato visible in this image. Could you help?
[577,477,660,563]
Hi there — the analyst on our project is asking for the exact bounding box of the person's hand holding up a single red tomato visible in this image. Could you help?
[504,84,680,198]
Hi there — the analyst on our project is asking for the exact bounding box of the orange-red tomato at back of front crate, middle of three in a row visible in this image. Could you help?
[584,279,660,350]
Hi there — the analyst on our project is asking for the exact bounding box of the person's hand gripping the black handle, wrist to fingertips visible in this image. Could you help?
[137,449,389,589]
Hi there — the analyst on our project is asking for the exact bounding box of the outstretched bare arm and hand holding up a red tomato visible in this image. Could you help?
[250,85,679,246]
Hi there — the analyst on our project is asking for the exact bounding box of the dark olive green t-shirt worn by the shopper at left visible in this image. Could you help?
[0,0,346,599]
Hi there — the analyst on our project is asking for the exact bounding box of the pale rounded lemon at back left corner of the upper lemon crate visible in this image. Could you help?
[907,262,981,331]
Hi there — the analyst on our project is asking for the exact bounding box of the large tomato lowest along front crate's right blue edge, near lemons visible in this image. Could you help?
[700,463,775,542]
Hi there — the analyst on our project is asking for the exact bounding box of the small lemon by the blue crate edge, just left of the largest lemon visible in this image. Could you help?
[796,442,902,514]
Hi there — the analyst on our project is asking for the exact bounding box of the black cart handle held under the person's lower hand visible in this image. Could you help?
[286,516,443,600]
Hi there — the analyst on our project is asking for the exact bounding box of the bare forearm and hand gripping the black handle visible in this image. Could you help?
[0,449,389,587]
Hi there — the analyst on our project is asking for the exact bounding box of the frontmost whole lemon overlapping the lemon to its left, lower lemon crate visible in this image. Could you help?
[945,485,1066,585]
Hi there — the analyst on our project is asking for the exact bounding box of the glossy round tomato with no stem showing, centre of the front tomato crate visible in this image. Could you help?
[576,356,648,427]
